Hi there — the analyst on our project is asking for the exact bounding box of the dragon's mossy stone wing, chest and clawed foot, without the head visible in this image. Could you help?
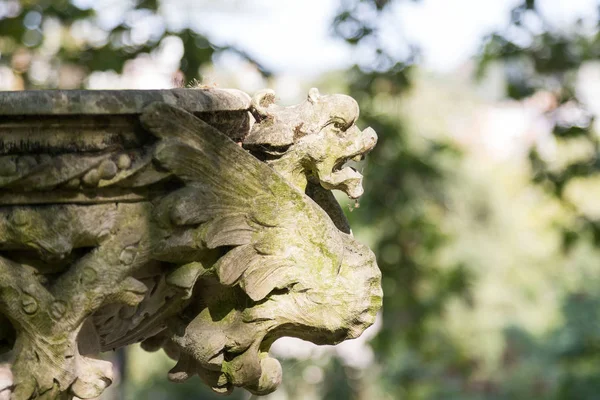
[135,103,381,394]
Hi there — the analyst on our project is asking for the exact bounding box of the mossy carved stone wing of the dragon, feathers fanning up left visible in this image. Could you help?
[141,103,343,301]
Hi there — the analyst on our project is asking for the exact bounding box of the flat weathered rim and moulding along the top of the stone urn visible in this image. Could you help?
[0,89,252,155]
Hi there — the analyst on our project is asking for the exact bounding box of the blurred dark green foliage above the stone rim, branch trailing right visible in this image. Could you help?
[0,0,269,89]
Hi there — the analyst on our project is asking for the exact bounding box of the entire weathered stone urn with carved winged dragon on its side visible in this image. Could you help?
[0,89,382,400]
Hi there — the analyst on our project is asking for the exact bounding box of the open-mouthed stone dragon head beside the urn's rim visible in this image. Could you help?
[243,88,377,198]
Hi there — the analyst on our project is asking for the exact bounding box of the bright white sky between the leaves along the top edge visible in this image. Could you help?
[169,0,597,76]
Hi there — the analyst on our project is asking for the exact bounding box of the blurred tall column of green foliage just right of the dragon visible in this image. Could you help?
[333,0,472,399]
